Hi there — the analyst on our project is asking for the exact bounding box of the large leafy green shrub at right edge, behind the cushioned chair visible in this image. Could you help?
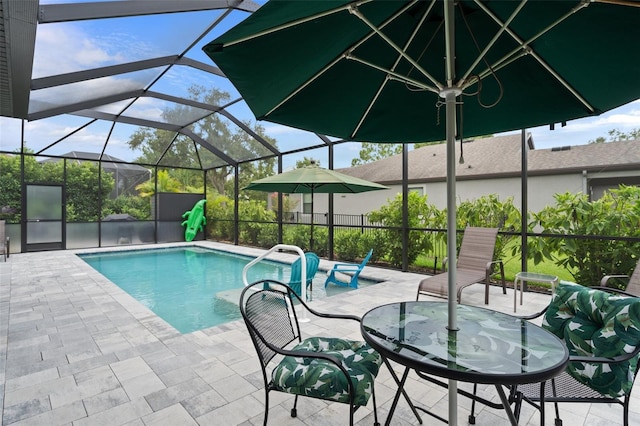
[528,185,640,286]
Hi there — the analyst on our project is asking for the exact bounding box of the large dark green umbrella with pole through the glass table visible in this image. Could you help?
[204,0,640,423]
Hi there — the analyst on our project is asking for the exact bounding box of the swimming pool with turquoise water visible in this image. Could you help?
[78,246,374,333]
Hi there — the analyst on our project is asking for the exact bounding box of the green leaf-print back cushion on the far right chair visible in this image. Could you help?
[542,281,640,397]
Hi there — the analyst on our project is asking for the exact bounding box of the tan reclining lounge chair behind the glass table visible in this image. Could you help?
[416,227,507,304]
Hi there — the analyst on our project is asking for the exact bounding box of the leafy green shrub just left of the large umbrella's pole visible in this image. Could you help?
[369,192,441,266]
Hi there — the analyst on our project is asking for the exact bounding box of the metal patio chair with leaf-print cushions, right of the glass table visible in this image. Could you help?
[512,282,640,426]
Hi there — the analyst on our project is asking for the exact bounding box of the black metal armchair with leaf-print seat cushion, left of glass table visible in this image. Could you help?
[240,280,382,425]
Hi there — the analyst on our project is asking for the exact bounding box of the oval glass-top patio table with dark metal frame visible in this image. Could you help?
[360,301,569,424]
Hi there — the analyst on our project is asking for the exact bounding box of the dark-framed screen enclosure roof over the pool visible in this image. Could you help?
[0,0,339,169]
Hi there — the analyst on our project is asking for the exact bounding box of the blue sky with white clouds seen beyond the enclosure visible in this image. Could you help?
[0,2,640,169]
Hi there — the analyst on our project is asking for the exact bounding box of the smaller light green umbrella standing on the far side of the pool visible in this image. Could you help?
[243,166,388,250]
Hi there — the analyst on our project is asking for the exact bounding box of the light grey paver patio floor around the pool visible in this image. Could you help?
[0,242,640,426]
